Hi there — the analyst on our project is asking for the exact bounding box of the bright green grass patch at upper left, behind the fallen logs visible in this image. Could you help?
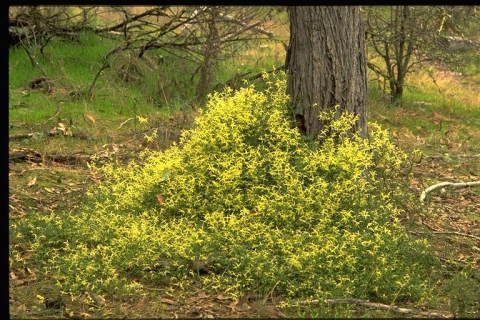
[9,33,191,125]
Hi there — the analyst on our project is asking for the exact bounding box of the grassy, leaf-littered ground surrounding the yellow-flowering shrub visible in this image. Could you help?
[9,11,480,319]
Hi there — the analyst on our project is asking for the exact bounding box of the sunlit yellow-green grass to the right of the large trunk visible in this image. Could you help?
[369,68,480,158]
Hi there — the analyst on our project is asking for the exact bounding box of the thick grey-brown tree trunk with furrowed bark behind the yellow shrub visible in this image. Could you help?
[285,6,367,137]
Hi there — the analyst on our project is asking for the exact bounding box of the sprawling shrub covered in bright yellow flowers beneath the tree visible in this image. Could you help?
[10,74,435,303]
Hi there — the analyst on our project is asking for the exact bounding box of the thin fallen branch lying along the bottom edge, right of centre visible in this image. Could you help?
[290,298,452,318]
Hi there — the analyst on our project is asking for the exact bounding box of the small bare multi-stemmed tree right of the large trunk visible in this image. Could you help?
[362,6,480,103]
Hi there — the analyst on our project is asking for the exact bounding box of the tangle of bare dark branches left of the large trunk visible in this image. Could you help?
[10,6,275,104]
